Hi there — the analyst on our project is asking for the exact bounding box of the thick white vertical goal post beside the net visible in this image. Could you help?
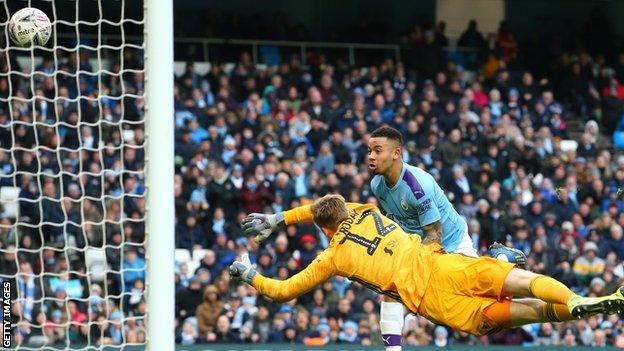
[144,0,175,351]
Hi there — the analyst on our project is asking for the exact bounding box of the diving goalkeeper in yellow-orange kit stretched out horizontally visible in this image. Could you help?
[230,195,624,335]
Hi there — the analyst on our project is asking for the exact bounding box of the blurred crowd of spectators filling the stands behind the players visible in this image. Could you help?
[0,18,624,346]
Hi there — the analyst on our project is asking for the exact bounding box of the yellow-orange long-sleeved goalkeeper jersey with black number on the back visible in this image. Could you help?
[252,203,441,312]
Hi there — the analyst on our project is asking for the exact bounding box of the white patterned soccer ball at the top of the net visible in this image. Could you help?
[9,7,52,46]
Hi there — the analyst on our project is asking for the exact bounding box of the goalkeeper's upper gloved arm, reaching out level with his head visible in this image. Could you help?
[242,202,358,244]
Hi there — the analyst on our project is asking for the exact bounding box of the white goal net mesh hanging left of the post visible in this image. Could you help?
[0,0,145,350]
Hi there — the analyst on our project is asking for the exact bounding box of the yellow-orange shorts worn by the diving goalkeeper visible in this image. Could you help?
[418,254,515,335]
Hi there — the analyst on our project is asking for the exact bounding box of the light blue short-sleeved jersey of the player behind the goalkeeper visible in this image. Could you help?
[371,162,466,252]
